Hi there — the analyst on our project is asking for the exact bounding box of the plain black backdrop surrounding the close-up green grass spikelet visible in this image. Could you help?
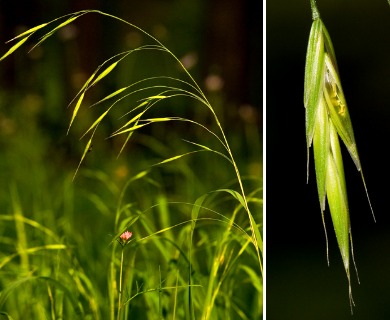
[266,0,390,320]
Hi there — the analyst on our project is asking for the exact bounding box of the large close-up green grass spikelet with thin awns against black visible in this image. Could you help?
[304,0,375,312]
